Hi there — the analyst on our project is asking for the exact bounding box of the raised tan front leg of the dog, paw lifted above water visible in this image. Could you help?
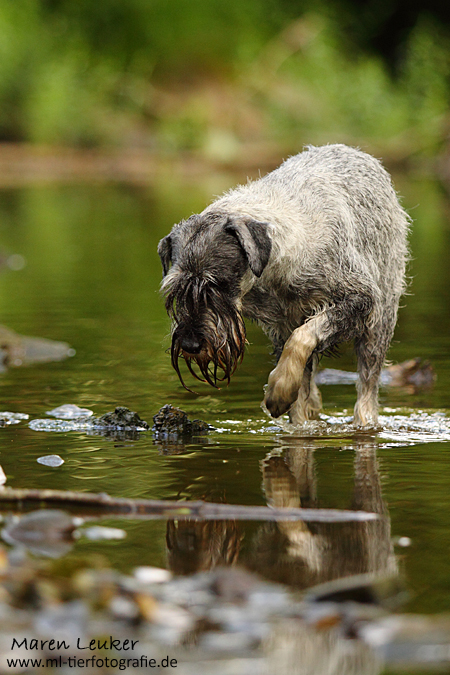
[264,318,320,417]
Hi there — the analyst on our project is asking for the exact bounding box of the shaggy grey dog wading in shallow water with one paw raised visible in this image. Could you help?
[158,145,409,426]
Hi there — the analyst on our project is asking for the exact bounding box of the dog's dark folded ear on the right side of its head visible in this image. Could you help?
[225,218,272,277]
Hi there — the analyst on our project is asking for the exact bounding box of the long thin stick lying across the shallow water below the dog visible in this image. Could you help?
[0,488,378,523]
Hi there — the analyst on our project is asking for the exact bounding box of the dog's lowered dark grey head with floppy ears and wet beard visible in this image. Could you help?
[158,213,271,389]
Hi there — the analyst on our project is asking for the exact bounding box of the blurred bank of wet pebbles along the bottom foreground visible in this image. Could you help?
[0,548,444,675]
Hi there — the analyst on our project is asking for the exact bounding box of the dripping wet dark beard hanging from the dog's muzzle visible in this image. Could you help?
[166,278,246,391]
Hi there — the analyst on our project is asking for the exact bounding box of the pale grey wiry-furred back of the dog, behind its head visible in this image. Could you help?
[205,145,409,296]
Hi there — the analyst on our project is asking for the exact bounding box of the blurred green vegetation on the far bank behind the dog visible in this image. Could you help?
[0,0,450,164]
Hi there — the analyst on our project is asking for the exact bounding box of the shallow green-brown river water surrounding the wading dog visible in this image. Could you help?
[0,176,450,664]
